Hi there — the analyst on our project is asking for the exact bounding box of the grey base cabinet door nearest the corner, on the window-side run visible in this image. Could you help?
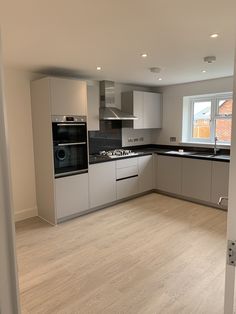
[156,155,182,194]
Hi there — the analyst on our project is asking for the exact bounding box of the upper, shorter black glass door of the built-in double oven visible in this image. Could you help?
[52,122,87,144]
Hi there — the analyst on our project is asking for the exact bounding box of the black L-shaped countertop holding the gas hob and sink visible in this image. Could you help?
[89,146,230,165]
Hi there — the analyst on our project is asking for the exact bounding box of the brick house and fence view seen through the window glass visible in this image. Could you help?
[192,99,233,142]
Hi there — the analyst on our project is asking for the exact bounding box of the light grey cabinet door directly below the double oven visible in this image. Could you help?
[55,173,89,219]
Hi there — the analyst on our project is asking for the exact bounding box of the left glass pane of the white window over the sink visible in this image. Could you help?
[192,101,211,139]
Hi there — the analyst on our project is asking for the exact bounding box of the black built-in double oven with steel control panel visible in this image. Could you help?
[52,116,88,178]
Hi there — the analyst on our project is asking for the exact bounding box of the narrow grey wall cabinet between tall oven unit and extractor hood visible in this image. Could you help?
[87,81,100,131]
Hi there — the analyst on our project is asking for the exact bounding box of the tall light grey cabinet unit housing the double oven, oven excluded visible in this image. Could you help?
[31,77,88,224]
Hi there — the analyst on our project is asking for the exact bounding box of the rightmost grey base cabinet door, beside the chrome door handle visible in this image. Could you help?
[211,161,229,204]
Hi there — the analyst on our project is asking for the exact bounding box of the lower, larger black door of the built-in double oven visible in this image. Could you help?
[54,143,88,178]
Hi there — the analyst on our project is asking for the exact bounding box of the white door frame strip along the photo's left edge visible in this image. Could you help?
[0,30,20,314]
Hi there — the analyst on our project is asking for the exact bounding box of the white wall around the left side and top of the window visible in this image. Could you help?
[152,77,233,145]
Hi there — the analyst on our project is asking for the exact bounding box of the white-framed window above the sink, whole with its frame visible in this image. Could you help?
[183,93,233,144]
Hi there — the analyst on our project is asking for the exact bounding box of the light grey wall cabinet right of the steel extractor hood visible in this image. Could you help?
[121,91,162,129]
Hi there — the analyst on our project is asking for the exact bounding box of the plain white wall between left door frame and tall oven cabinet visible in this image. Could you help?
[4,69,38,220]
